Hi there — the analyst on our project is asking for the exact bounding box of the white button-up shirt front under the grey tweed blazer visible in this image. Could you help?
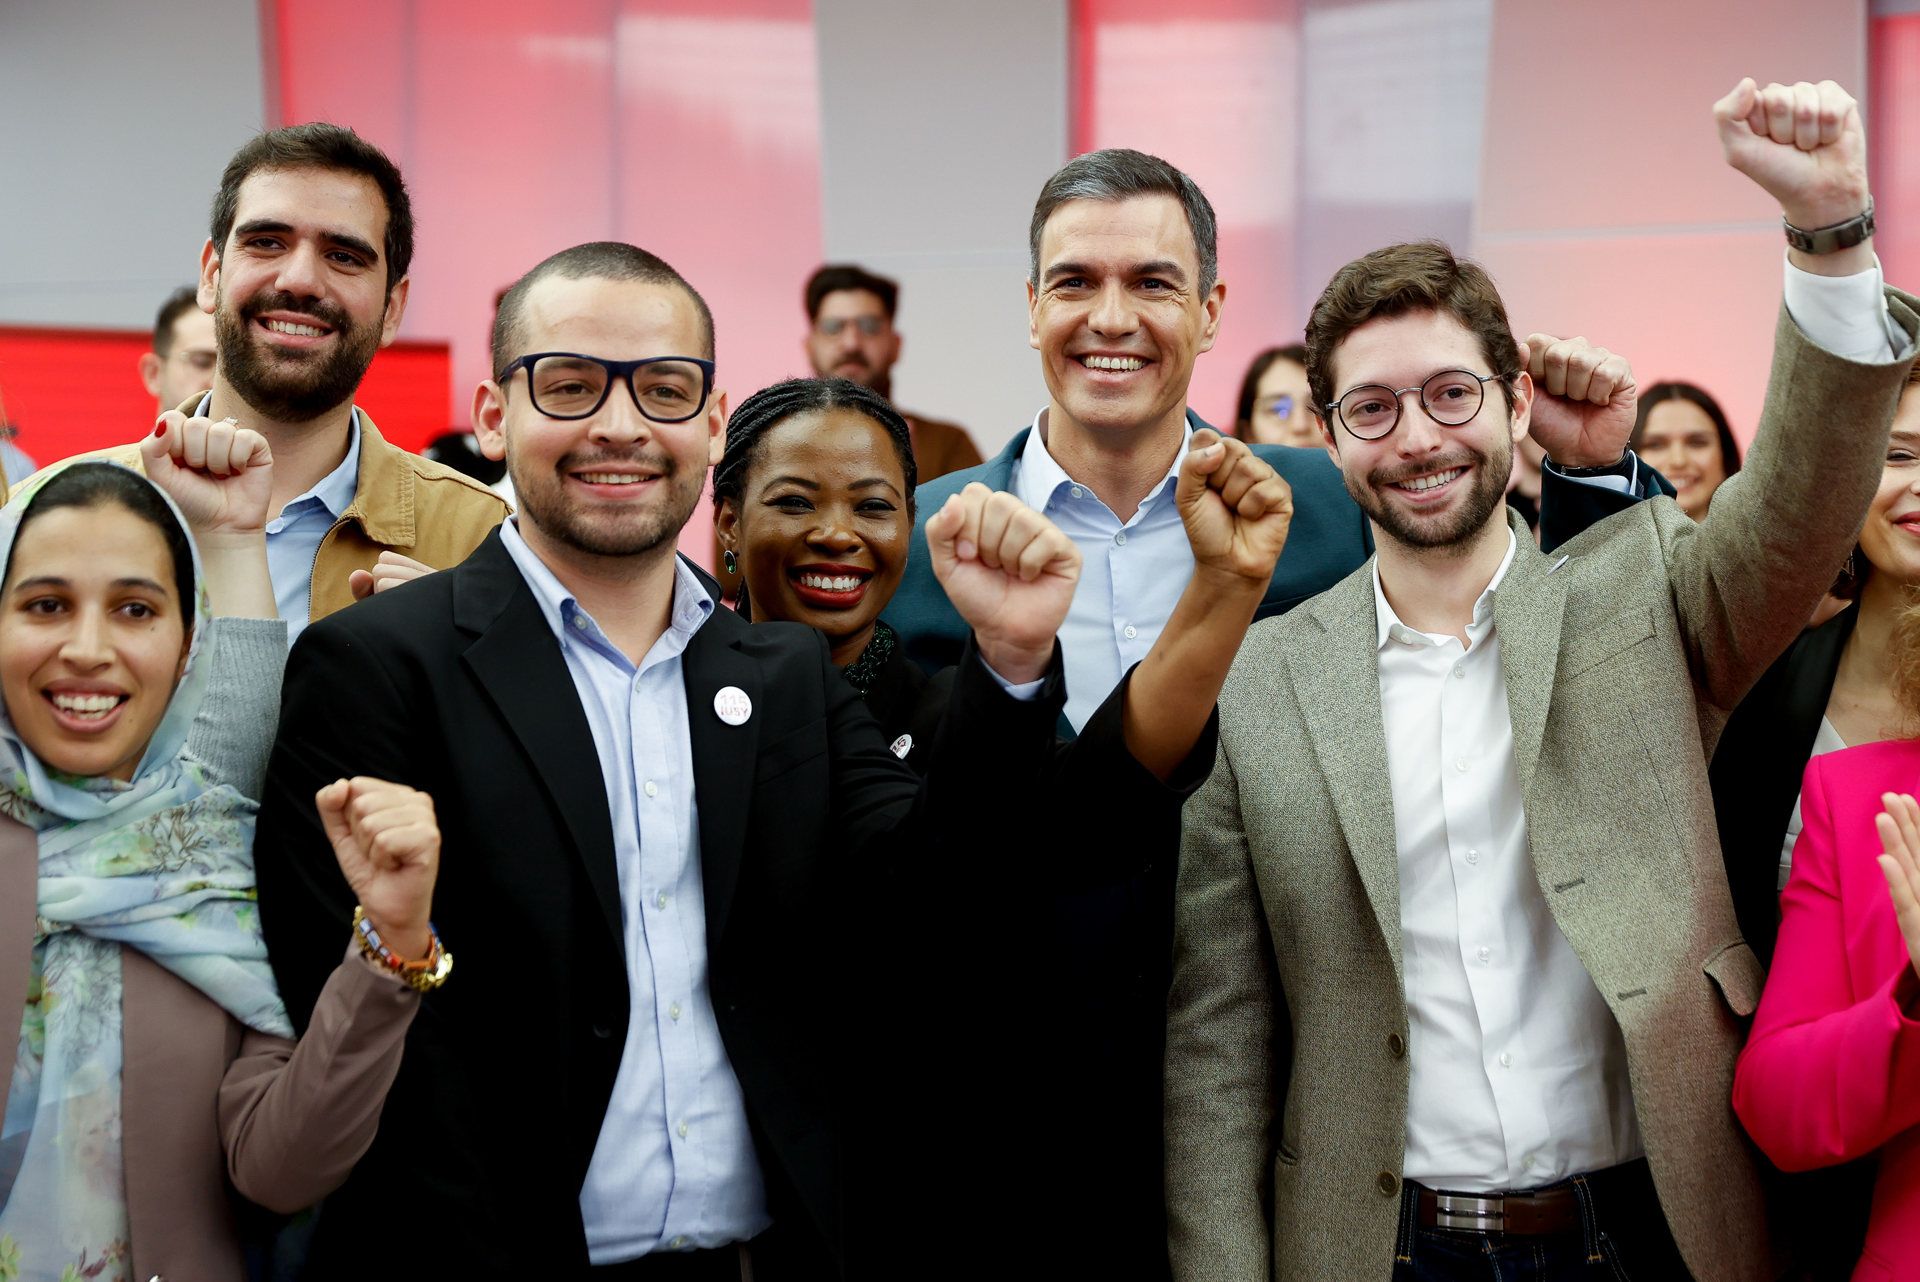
[1373,532,1644,1192]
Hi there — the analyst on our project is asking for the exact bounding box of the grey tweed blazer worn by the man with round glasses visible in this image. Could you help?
[1165,294,1920,1282]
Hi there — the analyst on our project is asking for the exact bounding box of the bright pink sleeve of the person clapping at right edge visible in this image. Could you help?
[1734,756,1920,1171]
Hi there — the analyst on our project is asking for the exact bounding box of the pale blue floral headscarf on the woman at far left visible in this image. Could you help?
[0,463,292,1278]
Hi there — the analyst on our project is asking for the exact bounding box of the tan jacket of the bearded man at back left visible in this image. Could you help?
[11,395,509,620]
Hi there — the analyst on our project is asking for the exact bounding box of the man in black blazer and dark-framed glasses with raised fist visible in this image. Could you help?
[259,244,1079,1282]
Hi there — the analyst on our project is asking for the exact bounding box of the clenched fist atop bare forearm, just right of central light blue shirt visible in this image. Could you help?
[1173,428,1294,583]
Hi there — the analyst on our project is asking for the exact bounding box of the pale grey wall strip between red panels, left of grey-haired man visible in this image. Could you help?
[810,0,1068,455]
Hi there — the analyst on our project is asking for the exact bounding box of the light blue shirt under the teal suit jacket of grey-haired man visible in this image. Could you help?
[1008,409,1194,731]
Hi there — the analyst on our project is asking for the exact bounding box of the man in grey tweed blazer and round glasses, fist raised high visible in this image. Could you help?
[1165,81,1920,1282]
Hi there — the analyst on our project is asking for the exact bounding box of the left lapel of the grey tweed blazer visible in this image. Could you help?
[1284,562,1402,975]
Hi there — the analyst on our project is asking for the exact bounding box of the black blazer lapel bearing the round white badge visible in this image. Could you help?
[680,608,766,946]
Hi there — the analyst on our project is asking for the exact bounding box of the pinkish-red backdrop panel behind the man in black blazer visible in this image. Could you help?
[269,0,822,562]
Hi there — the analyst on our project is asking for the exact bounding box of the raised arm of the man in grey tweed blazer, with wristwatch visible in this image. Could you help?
[1653,81,1920,708]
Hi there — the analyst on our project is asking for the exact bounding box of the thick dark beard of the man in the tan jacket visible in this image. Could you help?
[213,294,386,422]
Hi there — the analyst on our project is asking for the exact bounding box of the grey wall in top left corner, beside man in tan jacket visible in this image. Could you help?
[0,0,263,328]
